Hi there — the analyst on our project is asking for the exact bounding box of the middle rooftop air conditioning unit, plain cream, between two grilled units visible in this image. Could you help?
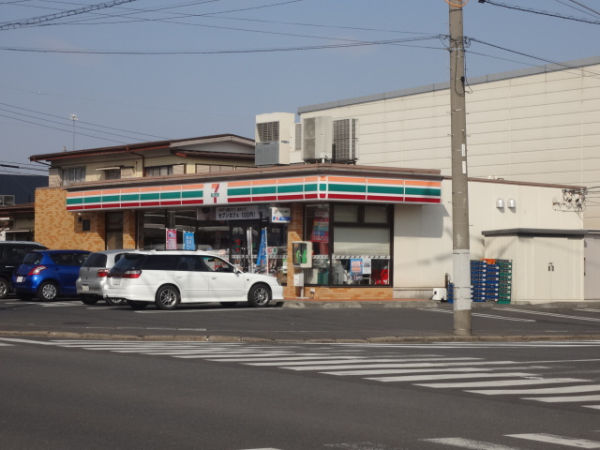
[302,116,333,162]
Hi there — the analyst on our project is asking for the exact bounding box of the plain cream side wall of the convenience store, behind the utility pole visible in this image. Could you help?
[394,180,583,298]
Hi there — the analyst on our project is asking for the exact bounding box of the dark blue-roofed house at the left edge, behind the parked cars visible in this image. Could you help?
[0,174,48,241]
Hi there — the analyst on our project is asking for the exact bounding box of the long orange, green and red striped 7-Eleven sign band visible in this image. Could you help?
[67,175,442,211]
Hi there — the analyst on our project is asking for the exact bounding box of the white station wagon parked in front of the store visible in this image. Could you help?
[106,250,283,309]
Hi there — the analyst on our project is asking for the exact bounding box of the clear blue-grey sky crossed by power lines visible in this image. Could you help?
[0,0,600,175]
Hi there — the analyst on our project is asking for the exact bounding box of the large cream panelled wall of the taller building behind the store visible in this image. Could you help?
[300,58,600,228]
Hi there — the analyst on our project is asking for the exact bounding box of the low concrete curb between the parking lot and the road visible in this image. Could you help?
[0,330,600,344]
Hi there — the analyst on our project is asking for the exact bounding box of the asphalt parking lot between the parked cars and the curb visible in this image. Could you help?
[0,298,600,341]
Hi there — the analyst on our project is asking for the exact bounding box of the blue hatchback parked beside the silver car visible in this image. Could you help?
[12,250,90,301]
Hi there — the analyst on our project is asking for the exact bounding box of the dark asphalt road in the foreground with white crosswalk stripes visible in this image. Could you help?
[0,336,600,450]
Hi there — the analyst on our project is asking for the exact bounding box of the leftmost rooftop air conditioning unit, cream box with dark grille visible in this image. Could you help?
[254,113,295,166]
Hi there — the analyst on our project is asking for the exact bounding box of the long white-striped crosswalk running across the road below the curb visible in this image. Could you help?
[0,338,600,410]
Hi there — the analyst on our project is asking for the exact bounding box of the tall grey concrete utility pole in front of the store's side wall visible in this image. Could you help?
[446,0,471,336]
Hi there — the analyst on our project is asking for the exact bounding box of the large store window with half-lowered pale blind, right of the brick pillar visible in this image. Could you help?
[304,203,392,286]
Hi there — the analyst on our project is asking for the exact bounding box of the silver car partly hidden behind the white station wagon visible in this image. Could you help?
[75,249,135,305]
